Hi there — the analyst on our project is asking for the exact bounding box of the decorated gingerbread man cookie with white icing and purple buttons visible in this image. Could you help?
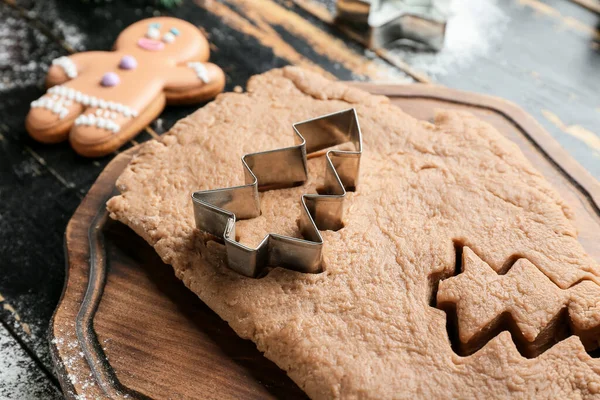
[26,17,225,157]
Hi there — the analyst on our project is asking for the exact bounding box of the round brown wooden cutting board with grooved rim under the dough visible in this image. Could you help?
[50,83,600,399]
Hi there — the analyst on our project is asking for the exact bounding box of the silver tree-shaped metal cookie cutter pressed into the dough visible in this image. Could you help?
[192,108,362,277]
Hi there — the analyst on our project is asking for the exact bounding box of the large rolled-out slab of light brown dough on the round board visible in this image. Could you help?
[108,67,600,399]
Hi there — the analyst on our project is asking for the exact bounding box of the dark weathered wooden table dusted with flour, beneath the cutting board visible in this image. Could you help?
[0,0,600,399]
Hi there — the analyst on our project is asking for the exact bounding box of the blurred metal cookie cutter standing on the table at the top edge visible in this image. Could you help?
[336,0,450,51]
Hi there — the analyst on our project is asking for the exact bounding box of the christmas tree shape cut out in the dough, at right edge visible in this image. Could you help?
[437,247,600,358]
